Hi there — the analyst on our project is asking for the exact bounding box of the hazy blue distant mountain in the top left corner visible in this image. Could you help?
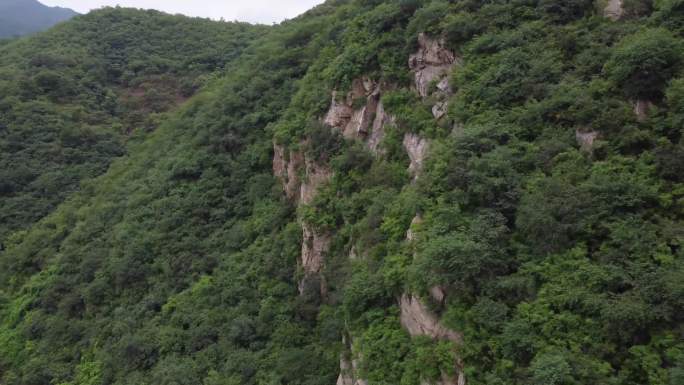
[0,0,78,38]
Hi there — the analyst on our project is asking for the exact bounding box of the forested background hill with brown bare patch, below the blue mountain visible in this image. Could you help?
[0,9,263,243]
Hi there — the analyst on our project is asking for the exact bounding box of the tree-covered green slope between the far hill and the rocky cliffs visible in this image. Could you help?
[0,3,337,384]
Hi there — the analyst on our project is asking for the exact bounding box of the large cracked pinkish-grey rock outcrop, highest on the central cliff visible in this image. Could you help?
[409,33,457,97]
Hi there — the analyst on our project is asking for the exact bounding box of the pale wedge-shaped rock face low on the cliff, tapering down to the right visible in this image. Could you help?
[399,294,463,343]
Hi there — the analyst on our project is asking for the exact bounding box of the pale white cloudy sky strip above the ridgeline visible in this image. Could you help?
[39,0,323,24]
